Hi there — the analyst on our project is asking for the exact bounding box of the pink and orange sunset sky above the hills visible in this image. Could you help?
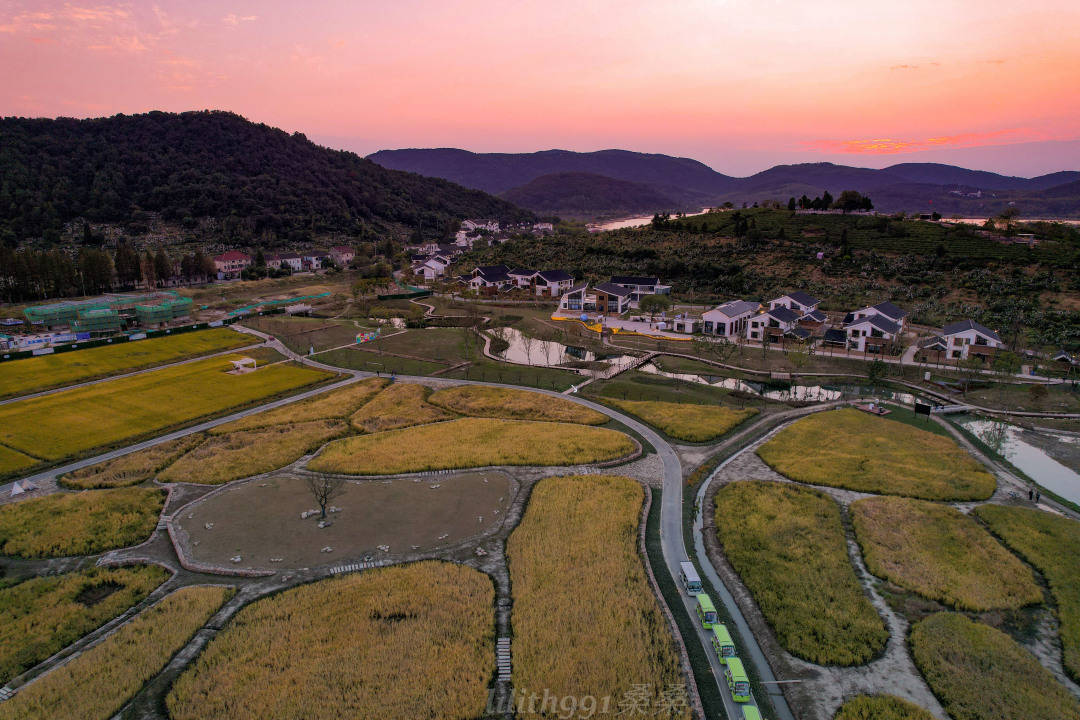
[0,0,1080,176]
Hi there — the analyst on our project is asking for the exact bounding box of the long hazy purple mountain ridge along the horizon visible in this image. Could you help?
[368,148,1080,217]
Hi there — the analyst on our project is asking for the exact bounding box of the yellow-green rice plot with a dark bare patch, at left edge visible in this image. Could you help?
[0,566,168,683]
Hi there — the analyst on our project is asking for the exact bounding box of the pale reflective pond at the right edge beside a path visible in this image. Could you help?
[957,416,1080,504]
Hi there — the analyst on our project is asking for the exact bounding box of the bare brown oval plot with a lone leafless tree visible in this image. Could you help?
[177,472,513,570]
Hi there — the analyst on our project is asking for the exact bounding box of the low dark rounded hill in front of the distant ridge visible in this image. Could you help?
[500,173,678,219]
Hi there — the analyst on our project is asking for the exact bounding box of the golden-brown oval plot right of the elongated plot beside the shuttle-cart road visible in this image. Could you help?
[851,497,1042,612]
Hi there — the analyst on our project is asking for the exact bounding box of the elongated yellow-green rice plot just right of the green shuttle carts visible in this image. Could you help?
[715,480,889,665]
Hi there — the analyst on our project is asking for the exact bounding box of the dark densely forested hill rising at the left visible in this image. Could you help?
[0,111,531,246]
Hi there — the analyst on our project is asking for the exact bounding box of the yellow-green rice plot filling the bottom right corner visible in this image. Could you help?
[908,612,1080,720]
